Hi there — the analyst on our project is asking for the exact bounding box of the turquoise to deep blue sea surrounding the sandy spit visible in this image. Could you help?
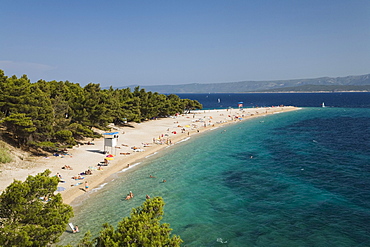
[61,93,370,247]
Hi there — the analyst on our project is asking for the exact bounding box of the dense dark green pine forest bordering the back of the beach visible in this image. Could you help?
[0,70,202,151]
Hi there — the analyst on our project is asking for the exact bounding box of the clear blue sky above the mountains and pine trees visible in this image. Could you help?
[0,0,370,87]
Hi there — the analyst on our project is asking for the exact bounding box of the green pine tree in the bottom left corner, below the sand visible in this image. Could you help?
[0,170,73,246]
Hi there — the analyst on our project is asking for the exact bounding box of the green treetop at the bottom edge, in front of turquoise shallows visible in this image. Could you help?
[78,197,182,247]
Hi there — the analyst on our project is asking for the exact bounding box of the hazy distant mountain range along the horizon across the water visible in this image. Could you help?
[123,74,370,94]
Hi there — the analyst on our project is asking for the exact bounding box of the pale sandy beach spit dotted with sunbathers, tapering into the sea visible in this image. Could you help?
[0,106,298,204]
